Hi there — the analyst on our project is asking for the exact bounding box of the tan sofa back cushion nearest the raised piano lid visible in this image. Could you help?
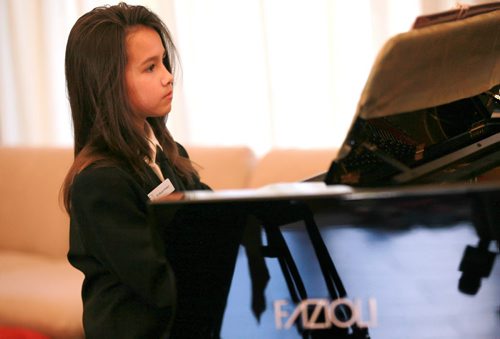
[248,148,338,188]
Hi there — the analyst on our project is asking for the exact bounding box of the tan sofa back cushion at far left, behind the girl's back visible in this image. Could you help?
[0,147,73,257]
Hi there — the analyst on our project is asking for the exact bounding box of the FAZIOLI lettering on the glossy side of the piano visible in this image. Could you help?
[274,298,377,330]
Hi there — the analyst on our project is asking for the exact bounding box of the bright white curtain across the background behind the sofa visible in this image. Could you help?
[0,0,487,153]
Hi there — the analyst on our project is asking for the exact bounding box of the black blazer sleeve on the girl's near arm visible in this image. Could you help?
[70,167,176,307]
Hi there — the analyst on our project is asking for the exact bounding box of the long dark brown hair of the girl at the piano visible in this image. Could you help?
[62,3,197,212]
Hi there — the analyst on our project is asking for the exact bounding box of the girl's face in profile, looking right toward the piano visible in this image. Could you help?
[125,26,173,123]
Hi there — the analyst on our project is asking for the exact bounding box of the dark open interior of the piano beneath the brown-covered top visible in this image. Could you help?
[325,83,500,187]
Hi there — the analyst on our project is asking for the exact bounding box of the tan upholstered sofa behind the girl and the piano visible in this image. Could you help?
[0,146,337,339]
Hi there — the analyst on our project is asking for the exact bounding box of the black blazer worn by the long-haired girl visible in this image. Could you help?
[68,145,208,338]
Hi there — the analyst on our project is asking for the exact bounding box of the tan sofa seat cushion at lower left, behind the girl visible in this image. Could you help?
[0,251,83,338]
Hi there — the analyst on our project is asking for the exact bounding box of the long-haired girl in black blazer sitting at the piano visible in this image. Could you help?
[63,3,219,338]
